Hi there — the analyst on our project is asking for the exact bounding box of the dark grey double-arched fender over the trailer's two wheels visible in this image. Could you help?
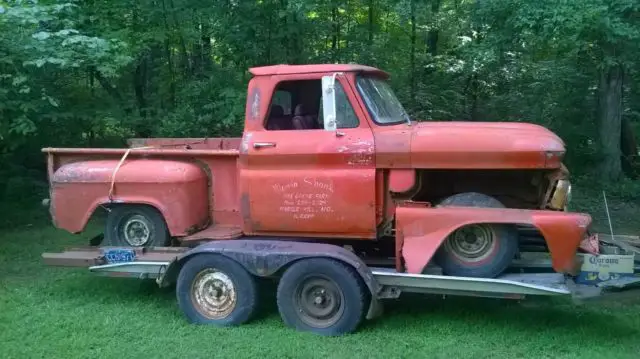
[159,238,382,319]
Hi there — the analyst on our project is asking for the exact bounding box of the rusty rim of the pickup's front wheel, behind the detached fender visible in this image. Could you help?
[445,224,497,262]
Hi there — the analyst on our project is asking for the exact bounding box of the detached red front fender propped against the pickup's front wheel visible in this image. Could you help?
[396,206,591,273]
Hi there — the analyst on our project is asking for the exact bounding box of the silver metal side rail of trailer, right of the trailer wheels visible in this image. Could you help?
[371,268,571,299]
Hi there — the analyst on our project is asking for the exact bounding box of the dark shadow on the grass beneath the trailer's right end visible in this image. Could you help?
[363,294,640,345]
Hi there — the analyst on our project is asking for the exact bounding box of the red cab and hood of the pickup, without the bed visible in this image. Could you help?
[240,65,570,239]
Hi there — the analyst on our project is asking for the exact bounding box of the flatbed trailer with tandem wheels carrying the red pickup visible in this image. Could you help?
[42,238,640,335]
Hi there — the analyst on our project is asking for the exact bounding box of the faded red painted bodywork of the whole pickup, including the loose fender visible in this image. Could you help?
[43,65,589,278]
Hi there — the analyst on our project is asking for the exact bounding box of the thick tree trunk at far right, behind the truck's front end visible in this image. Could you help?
[598,65,623,181]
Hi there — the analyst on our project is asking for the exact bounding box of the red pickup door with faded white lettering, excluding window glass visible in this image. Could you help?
[239,73,377,238]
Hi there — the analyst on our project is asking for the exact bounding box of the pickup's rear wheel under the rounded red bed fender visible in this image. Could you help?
[103,205,171,247]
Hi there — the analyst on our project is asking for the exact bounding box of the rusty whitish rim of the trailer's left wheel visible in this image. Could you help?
[191,268,238,320]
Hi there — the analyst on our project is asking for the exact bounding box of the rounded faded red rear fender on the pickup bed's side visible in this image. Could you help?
[50,159,210,236]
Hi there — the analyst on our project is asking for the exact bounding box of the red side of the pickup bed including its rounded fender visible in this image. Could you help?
[43,148,241,236]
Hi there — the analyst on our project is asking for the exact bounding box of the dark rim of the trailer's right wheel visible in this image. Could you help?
[294,277,344,328]
